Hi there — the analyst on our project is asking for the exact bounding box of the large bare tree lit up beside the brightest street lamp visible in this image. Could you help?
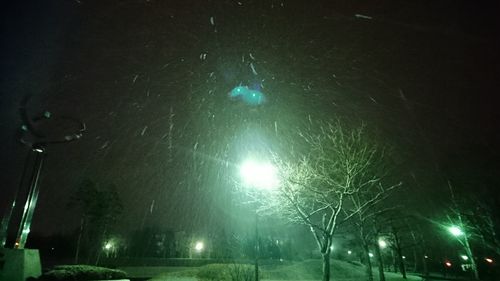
[266,122,398,281]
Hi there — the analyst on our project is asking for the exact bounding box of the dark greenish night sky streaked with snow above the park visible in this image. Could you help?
[0,0,500,236]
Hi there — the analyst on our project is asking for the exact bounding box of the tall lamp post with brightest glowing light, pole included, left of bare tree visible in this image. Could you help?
[240,159,279,281]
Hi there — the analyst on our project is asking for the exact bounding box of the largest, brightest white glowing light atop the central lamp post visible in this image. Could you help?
[240,160,279,189]
